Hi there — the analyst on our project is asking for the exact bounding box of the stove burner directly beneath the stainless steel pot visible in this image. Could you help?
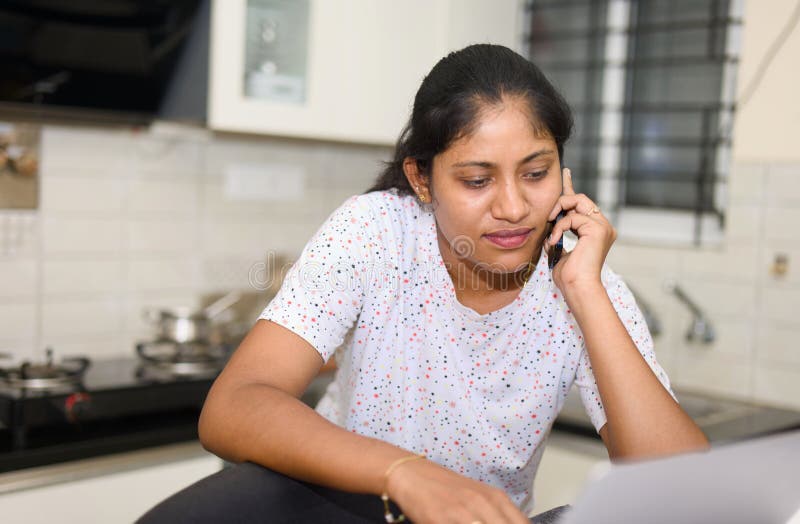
[136,341,229,379]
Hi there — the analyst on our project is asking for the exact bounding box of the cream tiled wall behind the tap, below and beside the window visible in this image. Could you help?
[609,162,800,408]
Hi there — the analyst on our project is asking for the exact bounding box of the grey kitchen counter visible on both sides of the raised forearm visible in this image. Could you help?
[553,388,800,444]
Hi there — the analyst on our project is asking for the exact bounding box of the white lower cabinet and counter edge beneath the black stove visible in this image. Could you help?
[0,442,222,524]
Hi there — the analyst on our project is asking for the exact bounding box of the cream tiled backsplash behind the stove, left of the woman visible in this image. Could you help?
[0,126,390,360]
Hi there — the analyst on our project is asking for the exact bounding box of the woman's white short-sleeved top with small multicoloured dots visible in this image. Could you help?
[260,190,669,510]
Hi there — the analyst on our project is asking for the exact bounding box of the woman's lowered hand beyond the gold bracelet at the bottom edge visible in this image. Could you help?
[387,460,530,524]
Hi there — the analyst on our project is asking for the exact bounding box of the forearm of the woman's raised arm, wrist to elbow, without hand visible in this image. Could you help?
[568,283,708,458]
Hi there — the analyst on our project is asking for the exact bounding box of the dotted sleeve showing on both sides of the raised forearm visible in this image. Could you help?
[575,266,677,431]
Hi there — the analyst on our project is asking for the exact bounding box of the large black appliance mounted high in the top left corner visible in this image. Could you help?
[0,0,209,123]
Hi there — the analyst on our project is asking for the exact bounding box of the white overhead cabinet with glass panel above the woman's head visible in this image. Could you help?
[208,0,521,144]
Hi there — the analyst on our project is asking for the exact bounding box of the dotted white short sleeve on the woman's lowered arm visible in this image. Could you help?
[259,195,381,362]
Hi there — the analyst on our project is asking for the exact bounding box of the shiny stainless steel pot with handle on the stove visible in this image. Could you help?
[144,291,241,344]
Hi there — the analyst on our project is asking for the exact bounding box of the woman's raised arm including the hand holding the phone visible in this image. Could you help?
[549,170,708,459]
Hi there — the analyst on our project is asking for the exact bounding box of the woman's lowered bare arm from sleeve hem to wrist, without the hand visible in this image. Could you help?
[199,320,409,494]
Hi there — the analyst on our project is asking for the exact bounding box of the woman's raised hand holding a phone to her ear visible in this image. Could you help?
[545,168,617,296]
